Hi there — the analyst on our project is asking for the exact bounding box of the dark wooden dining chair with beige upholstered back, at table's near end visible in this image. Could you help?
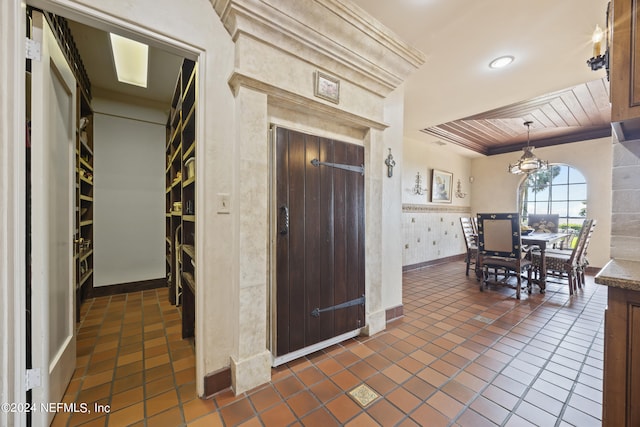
[476,213,531,299]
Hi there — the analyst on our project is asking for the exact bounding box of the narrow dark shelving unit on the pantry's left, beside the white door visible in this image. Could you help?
[74,86,94,318]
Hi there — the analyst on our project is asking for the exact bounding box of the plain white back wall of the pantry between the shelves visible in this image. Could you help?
[92,98,168,287]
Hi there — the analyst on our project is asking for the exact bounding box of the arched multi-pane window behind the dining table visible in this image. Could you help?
[518,164,587,230]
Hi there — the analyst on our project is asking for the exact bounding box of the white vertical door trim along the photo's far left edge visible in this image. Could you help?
[0,0,26,426]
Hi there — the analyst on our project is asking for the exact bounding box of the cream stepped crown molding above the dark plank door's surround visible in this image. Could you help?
[212,0,425,96]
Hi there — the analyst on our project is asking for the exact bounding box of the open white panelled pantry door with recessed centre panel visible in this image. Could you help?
[31,12,76,426]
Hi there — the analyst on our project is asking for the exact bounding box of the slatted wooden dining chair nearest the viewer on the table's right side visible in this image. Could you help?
[531,219,594,295]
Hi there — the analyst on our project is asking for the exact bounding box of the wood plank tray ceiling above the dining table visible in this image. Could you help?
[422,78,611,155]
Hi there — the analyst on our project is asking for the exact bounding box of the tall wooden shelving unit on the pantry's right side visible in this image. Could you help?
[165,59,197,338]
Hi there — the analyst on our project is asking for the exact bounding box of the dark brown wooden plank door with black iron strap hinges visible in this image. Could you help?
[275,128,365,356]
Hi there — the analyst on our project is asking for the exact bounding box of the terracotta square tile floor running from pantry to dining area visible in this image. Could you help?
[53,262,607,427]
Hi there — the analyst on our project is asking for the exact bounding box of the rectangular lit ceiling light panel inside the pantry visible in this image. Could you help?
[109,33,149,87]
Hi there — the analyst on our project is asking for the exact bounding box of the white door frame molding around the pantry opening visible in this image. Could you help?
[0,0,206,416]
